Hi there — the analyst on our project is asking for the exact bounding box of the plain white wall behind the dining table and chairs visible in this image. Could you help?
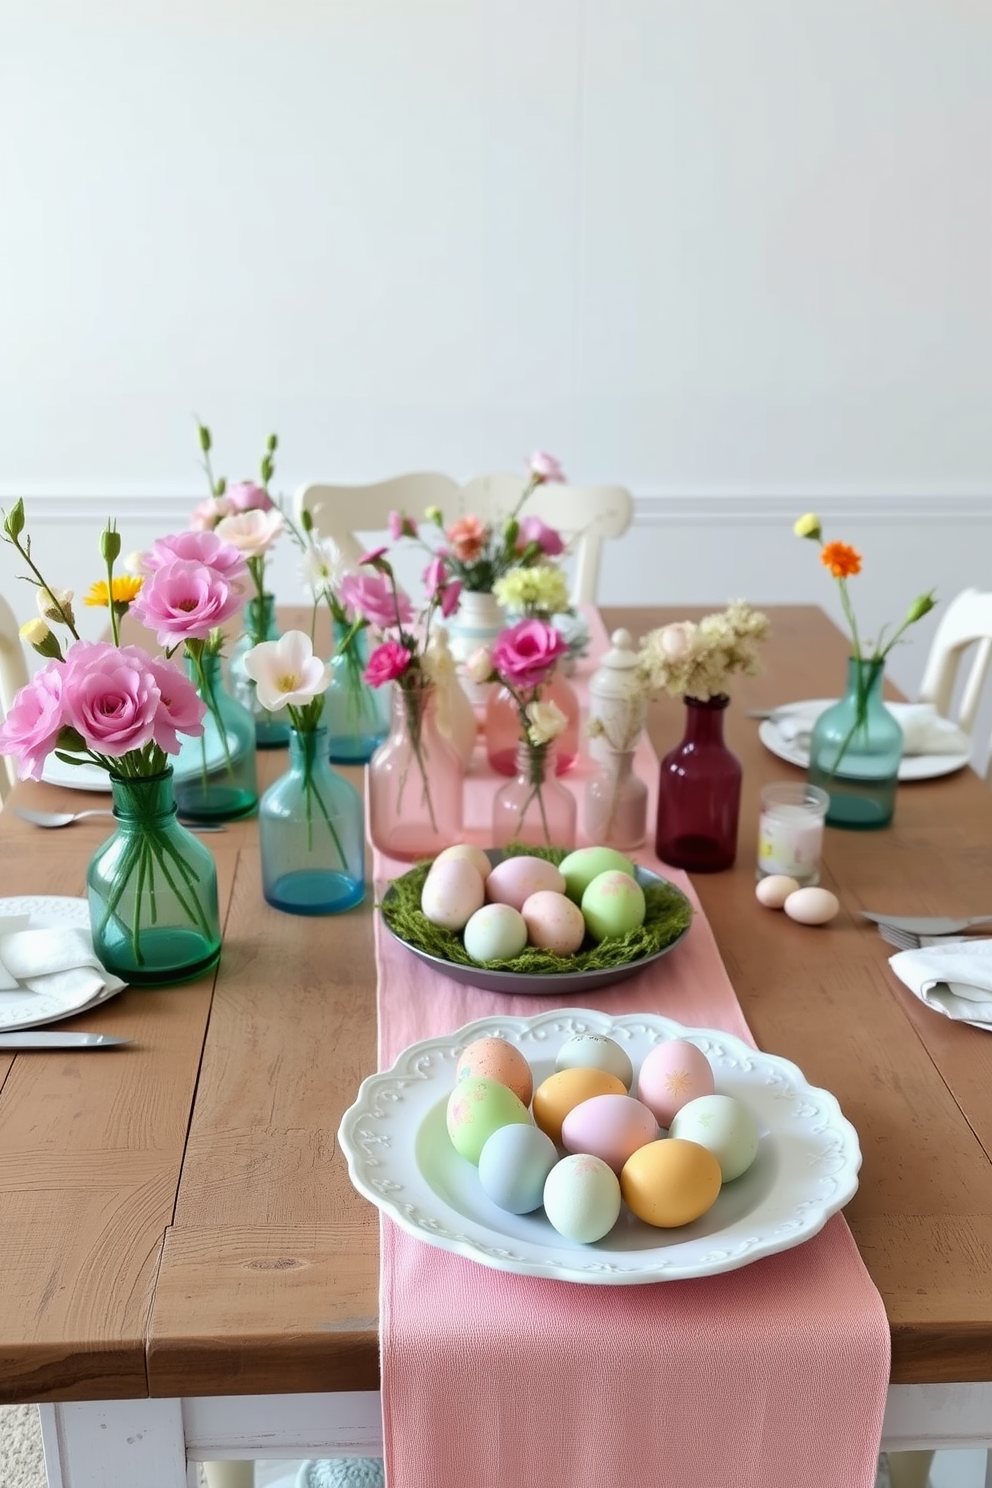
[0,0,992,732]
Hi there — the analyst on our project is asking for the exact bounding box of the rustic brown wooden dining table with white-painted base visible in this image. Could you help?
[0,607,992,1488]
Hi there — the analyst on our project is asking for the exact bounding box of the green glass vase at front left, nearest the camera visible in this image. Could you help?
[86,769,220,987]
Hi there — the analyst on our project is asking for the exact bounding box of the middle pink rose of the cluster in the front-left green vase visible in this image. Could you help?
[62,641,161,759]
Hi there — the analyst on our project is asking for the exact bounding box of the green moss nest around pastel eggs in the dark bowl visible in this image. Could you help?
[378,844,693,976]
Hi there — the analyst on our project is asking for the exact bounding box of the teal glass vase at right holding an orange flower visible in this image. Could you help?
[806,656,903,832]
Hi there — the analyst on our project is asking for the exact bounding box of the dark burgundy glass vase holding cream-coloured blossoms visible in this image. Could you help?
[656,693,741,873]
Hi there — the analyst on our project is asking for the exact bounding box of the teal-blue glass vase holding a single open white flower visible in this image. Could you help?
[259,726,364,915]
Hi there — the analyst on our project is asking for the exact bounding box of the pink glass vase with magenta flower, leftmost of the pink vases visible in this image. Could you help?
[367,682,464,862]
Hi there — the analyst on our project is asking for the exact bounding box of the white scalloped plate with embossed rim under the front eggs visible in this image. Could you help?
[338,1007,861,1286]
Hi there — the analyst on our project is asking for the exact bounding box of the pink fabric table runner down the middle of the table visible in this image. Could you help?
[375,619,889,1488]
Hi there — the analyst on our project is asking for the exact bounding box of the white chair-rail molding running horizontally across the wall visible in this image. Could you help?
[0,487,992,530]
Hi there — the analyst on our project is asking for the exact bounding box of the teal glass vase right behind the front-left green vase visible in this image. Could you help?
[174,656,259,821]
